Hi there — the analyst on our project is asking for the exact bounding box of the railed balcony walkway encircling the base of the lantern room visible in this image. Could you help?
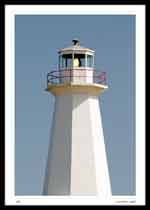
[47,68,106,87]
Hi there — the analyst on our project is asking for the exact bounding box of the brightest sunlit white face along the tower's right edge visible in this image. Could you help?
[89,96,112,198]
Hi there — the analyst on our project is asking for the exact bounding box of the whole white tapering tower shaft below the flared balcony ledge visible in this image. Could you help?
[44,94,111,198]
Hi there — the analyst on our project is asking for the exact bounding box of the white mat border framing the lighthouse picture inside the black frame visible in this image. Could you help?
[5,5,145,205]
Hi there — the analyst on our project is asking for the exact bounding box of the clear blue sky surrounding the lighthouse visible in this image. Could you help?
[15,15,135,195]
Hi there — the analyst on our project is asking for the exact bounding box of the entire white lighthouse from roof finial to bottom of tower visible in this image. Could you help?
[43,39,111,199]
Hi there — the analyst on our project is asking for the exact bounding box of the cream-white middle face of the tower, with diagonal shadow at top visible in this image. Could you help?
[70,94,97,195]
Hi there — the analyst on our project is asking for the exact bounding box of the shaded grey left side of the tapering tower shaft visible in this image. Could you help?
[43,95,72,195]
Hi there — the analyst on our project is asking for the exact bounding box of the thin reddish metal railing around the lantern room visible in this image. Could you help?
[47,69,106,86]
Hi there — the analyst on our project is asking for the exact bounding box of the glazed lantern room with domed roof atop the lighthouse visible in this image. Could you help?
[58,39,94,83]
